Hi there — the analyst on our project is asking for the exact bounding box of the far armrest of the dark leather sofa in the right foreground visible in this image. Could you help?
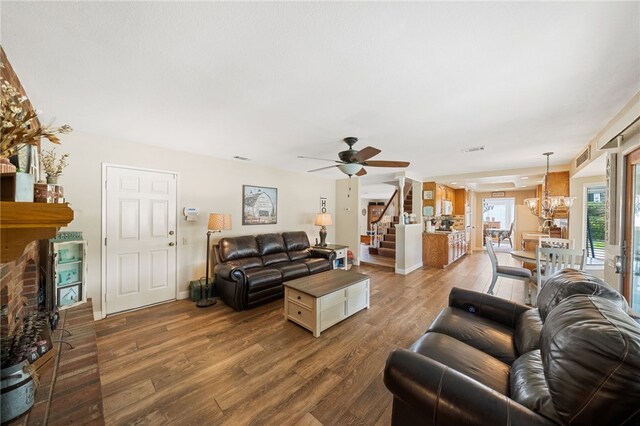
[449,287,532,328]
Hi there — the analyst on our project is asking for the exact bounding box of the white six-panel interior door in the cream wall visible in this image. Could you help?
[105,166,176,315]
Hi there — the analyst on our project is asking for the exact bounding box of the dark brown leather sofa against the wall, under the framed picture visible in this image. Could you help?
[213,231,336,311]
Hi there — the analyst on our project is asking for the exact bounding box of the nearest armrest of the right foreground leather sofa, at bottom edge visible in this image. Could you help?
[384,349,555,426]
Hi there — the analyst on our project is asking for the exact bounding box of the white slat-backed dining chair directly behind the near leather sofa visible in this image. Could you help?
[531,247,587,306]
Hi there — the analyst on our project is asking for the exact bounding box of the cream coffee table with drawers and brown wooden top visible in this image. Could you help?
[284,269,370,337]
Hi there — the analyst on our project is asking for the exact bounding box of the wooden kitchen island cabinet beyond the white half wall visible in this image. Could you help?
[422,231,469,268]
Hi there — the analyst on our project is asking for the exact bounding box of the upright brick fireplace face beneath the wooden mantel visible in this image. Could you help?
[0,241,40,337]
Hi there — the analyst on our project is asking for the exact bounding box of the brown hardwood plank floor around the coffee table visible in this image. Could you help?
[96,253,524,425]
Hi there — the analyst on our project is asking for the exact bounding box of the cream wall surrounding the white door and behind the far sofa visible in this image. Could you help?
[48,131,336,318]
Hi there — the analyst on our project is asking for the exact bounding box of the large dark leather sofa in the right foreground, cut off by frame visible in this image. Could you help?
[384,270,640,426]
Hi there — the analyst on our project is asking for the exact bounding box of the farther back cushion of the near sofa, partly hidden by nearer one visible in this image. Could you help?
[538,269,628,322]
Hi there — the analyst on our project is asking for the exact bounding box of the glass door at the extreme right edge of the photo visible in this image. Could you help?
[623,148,640,309]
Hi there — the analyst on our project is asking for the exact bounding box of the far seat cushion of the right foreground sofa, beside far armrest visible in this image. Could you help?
[427,307,518,364]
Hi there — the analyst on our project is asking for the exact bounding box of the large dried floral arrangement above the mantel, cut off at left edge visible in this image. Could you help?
[0,72,73,158]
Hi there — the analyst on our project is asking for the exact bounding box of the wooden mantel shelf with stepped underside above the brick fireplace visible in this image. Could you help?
[0,201,73,263]
